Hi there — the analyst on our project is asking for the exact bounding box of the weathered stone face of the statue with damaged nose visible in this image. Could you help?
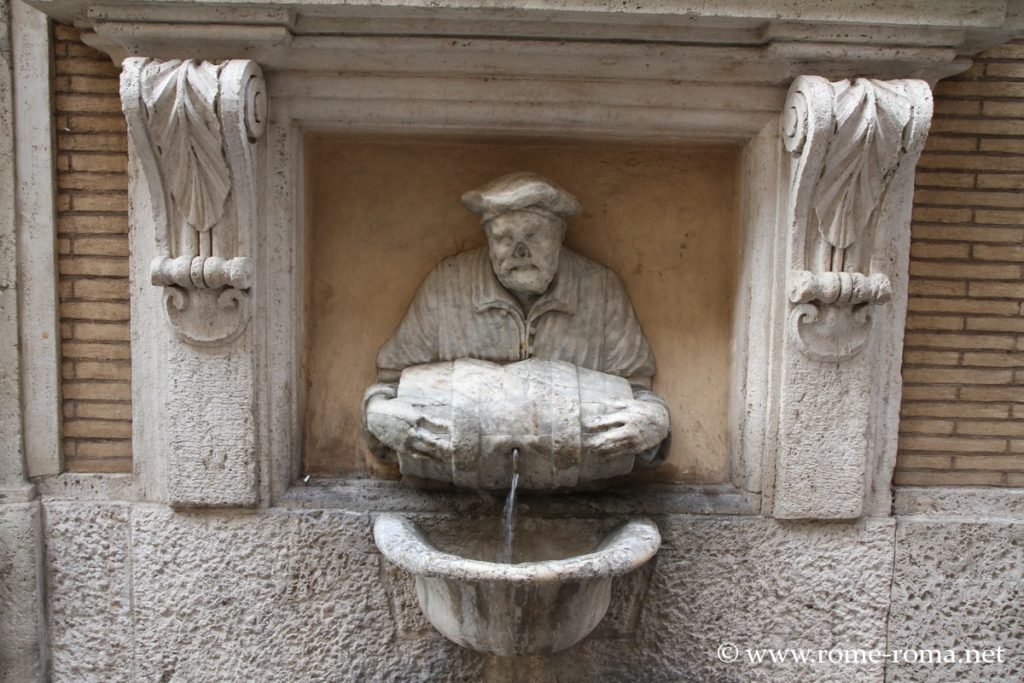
[486,211,562,295]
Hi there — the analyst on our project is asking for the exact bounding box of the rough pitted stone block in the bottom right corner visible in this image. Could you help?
[886,518,1024,683]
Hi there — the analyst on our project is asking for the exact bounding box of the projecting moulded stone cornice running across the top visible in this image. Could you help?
[29,0,1024,83]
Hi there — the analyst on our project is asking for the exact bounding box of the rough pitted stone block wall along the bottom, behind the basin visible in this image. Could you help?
[34,497,1024,683]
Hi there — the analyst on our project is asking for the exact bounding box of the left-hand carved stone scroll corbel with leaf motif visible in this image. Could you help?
[121,57,266,346]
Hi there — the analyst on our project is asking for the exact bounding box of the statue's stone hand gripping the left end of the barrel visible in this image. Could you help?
[367,396,452,460]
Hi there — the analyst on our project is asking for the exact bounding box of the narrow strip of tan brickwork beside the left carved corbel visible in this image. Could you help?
[54,25,131,472]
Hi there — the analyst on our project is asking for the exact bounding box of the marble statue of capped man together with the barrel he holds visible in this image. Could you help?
[364,172,669,488]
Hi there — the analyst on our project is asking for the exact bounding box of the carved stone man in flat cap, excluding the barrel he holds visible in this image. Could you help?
[365,173,669,479]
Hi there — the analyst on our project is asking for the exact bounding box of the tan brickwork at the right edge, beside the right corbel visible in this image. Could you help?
[895,41,1024,486]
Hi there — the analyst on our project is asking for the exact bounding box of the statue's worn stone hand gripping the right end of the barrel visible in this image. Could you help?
[582,399,669,457]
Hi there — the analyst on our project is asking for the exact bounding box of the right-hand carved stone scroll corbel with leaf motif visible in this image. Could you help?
[782,76,931,362]
